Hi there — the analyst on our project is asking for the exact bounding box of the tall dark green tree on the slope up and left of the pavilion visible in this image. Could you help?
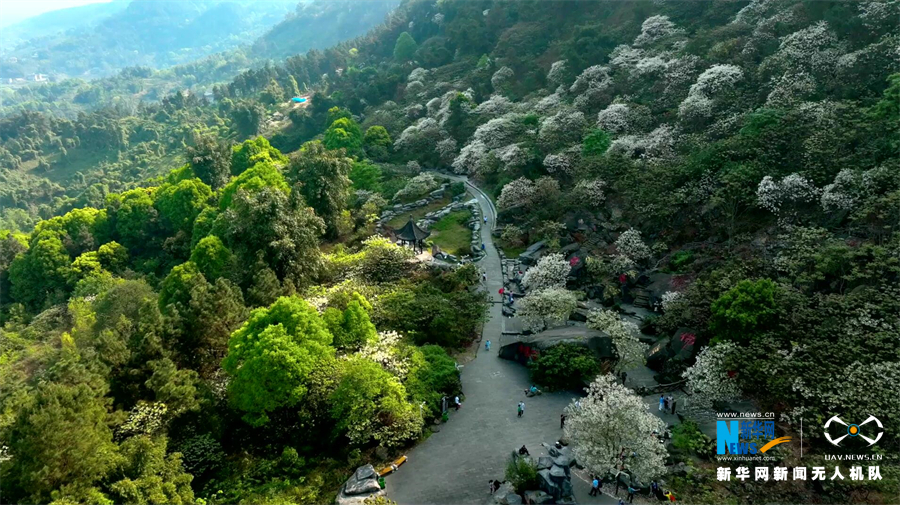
[290,141,353,236]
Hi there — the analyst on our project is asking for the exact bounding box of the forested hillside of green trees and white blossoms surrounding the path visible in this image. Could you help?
[0,0,900,503]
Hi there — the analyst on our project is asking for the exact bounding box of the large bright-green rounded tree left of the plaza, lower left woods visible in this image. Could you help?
[222,297,334,426]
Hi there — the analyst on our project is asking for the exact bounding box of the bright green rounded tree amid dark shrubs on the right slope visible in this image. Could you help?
[710,279,778,344]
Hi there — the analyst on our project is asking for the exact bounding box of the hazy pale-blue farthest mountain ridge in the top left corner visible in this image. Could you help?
[0,0,296,79]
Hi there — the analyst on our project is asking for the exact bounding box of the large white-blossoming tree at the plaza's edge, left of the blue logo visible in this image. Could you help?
[564,375,668,483]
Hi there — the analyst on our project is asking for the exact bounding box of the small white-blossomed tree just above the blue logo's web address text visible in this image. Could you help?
[682,342,741,405]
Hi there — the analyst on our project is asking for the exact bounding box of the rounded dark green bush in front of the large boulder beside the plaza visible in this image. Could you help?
[528,344,600,390]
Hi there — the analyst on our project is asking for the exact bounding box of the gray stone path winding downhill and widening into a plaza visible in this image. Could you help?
[385,177,624,505]
